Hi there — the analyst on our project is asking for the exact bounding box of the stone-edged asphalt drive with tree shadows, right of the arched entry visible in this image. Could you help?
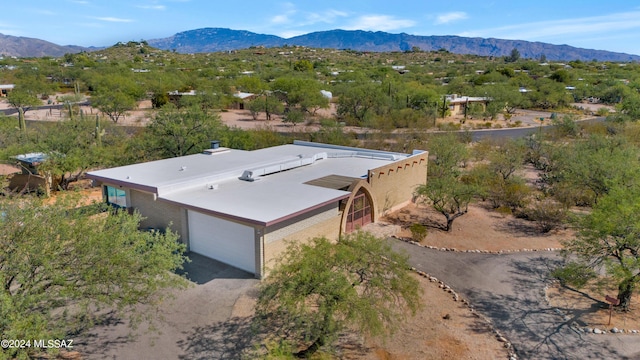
[390,240,640,359]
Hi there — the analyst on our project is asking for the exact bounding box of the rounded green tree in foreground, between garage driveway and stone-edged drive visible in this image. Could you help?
[256,232,420,357]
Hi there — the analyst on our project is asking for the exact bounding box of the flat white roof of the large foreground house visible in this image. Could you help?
[87,141,418,226]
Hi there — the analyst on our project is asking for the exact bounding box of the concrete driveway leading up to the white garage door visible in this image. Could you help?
[74,253,259,360]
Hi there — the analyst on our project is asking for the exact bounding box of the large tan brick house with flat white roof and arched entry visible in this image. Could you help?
[87,141,428,278]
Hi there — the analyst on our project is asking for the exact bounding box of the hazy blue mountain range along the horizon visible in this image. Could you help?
[0,28,640,62]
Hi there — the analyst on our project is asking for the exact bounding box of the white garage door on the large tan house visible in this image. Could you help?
[188,210,256,274]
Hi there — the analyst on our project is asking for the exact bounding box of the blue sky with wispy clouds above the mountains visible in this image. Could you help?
[0,0,640,55]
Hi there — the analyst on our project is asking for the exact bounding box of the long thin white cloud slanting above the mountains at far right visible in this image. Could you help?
[459,11,640,40]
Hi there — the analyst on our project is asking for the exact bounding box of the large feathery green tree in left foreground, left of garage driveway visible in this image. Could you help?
[0,197,186,358]
